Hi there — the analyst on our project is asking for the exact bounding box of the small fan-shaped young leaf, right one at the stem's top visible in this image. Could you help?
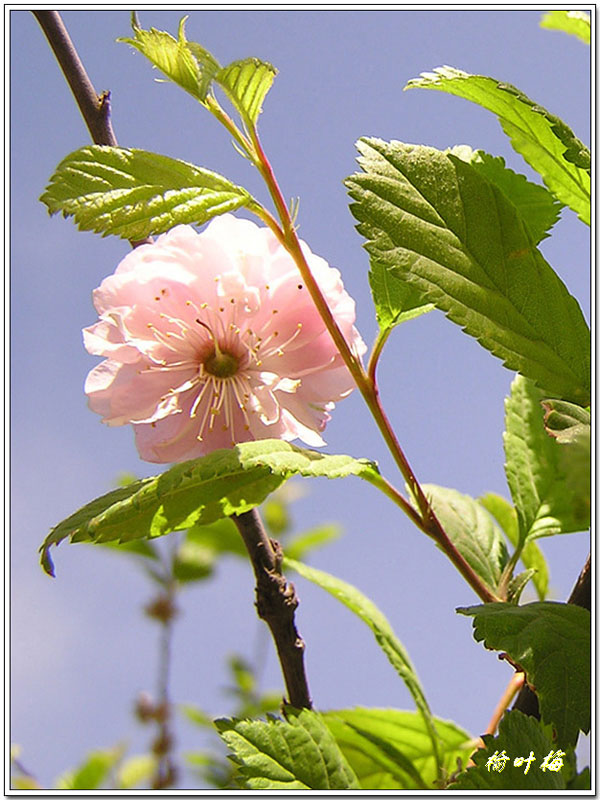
[216,58,277,125]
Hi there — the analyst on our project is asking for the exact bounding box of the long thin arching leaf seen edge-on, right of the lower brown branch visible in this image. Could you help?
[283,556,439,763]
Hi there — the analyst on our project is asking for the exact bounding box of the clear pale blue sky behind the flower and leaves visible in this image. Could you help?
[10,7,590,788]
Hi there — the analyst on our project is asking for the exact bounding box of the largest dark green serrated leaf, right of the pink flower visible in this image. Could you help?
[346,139,590,404]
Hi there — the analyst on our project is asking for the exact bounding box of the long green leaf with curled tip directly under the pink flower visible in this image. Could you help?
[41,439,381,574]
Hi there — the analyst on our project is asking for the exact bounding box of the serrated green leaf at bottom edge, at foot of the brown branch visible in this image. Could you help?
[215,710,360,791]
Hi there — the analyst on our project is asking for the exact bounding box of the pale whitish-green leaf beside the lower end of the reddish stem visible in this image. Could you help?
[423,484,508,590]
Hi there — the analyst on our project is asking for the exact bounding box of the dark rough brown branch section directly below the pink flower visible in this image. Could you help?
[232,509,312,708]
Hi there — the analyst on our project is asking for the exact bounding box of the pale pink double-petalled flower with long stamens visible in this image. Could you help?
[83,214,366,462]
